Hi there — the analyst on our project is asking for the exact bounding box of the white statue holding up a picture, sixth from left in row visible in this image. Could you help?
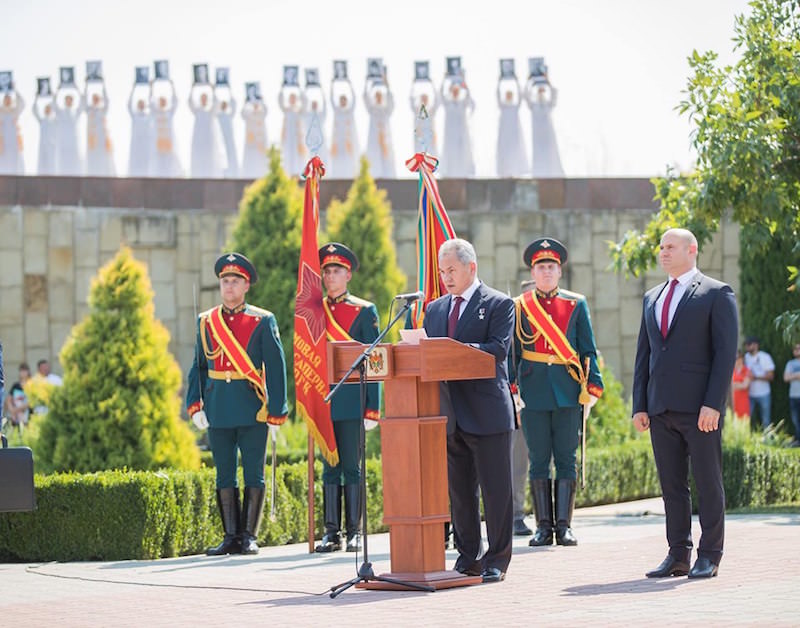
[150,61,183,178]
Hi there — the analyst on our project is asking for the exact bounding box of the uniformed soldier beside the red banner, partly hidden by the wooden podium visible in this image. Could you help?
[316,242,381,552]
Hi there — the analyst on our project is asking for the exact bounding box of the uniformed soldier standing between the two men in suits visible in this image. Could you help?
[512,238,603,547]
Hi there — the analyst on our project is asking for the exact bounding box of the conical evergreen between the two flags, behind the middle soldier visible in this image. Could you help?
[320,157,406,339]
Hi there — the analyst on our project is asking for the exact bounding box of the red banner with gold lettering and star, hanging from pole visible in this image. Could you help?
[294,156,339,465]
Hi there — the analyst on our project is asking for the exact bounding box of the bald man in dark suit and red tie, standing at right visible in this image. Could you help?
[633,229,738,578]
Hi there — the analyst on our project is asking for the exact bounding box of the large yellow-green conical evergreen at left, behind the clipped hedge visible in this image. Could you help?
[37,247,200,472]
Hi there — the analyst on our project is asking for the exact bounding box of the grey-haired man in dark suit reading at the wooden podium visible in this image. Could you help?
[425,238,514,582]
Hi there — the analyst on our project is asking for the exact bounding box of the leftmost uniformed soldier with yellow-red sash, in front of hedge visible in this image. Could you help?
[186,253,288,556]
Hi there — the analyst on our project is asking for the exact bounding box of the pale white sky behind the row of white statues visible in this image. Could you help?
[0,0,749,177]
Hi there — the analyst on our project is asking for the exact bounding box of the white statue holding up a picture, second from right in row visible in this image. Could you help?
[496,59,530,177]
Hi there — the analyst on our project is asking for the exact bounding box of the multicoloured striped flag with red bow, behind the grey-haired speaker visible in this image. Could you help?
[406,153,456,328]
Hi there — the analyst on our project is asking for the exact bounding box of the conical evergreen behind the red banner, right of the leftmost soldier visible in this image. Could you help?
[228,147,303,407]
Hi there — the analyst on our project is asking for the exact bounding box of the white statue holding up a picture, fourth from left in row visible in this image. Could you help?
[83,61,117,177]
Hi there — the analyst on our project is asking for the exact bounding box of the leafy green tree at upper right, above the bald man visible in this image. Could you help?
[611,0,800,350]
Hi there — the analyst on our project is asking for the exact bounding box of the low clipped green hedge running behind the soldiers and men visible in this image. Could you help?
[0,439,800,561]
